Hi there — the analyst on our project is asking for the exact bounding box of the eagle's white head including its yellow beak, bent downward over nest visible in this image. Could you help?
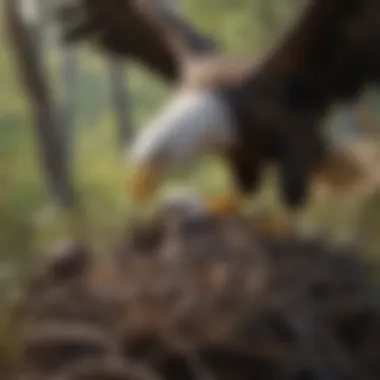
[127,90,236,201]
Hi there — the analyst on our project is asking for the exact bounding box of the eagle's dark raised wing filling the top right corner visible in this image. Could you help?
[254,0,380,101]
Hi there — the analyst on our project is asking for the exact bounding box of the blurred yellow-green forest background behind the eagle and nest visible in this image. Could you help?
[0,0,380,294]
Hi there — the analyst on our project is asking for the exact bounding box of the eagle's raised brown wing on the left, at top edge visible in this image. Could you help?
[55,0,215,81]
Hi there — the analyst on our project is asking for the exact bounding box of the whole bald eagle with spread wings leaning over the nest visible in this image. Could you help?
[57,0,380,214]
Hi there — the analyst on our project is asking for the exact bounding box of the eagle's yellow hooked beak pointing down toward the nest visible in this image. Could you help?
[128,166,160,203]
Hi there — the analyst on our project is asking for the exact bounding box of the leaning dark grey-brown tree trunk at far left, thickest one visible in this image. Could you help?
[5,0,74,206]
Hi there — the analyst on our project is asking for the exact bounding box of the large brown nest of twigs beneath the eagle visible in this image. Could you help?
[10,208,380,380]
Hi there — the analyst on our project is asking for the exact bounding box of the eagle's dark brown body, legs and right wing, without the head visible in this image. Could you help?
[203,0,380,205]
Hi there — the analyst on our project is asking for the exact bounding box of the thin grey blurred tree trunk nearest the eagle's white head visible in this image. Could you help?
[108,59,133,147]
